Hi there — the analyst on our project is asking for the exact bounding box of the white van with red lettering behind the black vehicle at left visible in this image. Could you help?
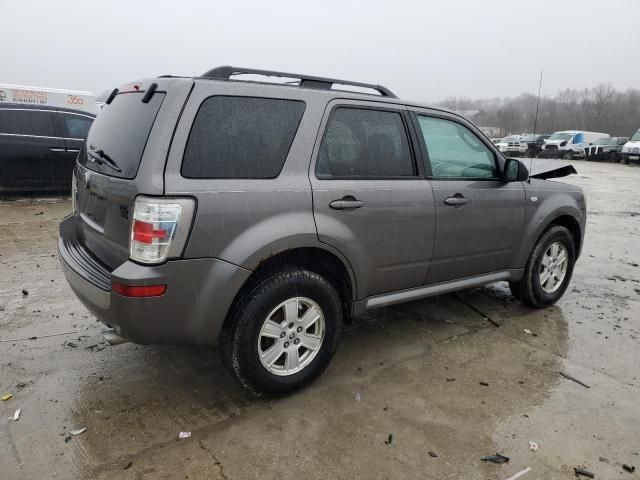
[0,83,97,115]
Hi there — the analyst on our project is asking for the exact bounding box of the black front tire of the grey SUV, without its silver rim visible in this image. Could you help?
[509,225,576,308]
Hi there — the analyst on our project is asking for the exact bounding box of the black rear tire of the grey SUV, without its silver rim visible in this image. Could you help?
[222,267,343,397]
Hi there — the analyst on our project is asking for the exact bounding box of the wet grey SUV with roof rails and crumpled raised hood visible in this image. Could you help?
[58,67,585,396]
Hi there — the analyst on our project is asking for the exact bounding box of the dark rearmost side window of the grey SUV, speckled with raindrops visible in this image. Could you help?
[182,96,305,178]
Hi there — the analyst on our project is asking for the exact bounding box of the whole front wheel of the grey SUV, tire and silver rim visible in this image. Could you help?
[509,225,576,308]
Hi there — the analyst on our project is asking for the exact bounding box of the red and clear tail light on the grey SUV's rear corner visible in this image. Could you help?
[129,197,195,264]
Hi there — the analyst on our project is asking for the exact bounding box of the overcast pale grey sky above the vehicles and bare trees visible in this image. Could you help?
[0,0,640,102]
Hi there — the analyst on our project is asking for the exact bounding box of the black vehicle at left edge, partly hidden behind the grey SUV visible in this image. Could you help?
[0,103,95,193]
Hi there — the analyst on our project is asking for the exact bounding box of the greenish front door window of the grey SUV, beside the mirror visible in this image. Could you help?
[418,116,497,178]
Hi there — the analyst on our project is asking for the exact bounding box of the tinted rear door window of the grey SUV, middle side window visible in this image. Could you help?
[316,107,415,178]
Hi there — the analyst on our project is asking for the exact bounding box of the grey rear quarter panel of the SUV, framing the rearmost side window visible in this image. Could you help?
[165,80,346,270]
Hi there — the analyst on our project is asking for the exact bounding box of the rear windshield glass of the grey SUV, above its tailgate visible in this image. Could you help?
[79,92,165,178]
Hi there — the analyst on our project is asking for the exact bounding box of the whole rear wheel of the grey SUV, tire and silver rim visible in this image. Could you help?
[222,268,342,397]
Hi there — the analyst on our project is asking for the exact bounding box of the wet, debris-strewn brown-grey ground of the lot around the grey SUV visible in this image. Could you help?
[0,162,640,479]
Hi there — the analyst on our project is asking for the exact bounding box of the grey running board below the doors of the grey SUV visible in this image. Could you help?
[364,270,522,310]
